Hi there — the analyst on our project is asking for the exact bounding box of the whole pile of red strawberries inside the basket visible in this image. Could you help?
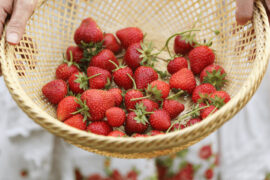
[42,18,230,137]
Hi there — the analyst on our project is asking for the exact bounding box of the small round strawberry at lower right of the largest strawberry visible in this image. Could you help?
[106,107,126,127]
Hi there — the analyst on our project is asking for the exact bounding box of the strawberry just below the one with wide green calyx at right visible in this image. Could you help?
[192,84,216,103]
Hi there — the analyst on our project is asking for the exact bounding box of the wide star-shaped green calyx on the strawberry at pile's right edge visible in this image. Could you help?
[203,69,227,90]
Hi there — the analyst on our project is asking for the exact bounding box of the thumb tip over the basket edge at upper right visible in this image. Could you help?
[236,0,254,25]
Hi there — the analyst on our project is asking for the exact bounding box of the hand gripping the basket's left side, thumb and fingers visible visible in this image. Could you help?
[0,0,37,45]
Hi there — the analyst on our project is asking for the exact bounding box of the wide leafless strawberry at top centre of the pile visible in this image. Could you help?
[116,27,143,49]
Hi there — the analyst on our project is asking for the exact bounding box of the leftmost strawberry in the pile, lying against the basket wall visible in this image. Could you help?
[42,79,67,104]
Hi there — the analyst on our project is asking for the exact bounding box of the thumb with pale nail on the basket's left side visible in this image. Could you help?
[6,0,36,45]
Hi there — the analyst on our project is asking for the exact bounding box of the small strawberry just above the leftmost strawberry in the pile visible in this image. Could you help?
[56,63,79,81]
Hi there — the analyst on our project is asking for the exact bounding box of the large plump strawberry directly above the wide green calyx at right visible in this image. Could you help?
[188,46,215,74]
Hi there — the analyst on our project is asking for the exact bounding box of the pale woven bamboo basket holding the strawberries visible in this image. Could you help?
[0,0,270,158]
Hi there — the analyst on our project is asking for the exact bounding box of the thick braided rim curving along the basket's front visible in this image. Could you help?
[1,1,270,158]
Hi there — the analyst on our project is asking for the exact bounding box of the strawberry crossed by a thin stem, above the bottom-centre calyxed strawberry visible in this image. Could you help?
[125,89,143,112]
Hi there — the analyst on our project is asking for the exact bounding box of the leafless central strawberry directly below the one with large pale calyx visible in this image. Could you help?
[134,66,158,89]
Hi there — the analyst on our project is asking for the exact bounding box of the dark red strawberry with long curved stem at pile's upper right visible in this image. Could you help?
[174,35,194,55]
